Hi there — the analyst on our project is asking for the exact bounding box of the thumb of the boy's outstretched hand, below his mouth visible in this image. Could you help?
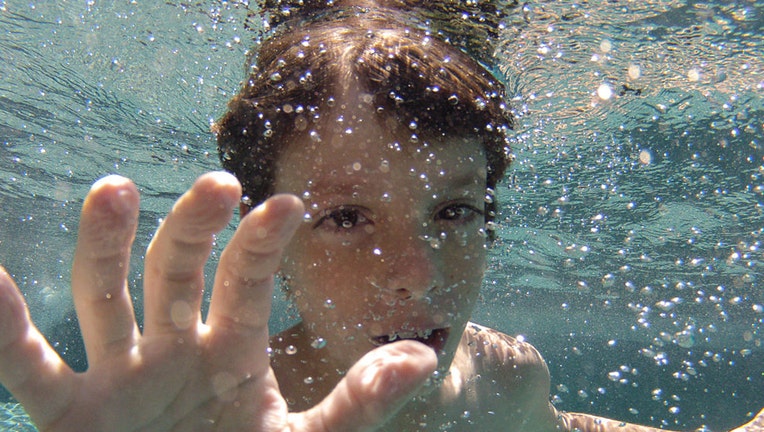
[290,340,438,432]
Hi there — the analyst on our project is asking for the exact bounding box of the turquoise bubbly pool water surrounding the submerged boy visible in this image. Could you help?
[0,0,764,430]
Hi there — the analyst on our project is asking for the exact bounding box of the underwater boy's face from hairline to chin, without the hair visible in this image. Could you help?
[275,107,486,368]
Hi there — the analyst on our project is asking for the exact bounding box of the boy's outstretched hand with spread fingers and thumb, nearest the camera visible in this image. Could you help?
[0,173,437,431]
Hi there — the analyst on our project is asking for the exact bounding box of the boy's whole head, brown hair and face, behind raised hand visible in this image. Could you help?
[216,11,511,369]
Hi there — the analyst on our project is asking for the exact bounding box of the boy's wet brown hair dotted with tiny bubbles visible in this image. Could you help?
[213,3,512,222]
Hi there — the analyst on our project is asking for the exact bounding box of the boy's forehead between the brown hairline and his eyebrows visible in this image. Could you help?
[275,93,487,189]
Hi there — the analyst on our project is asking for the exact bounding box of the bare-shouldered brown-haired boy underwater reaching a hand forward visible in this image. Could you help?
[0,0,764,431]
